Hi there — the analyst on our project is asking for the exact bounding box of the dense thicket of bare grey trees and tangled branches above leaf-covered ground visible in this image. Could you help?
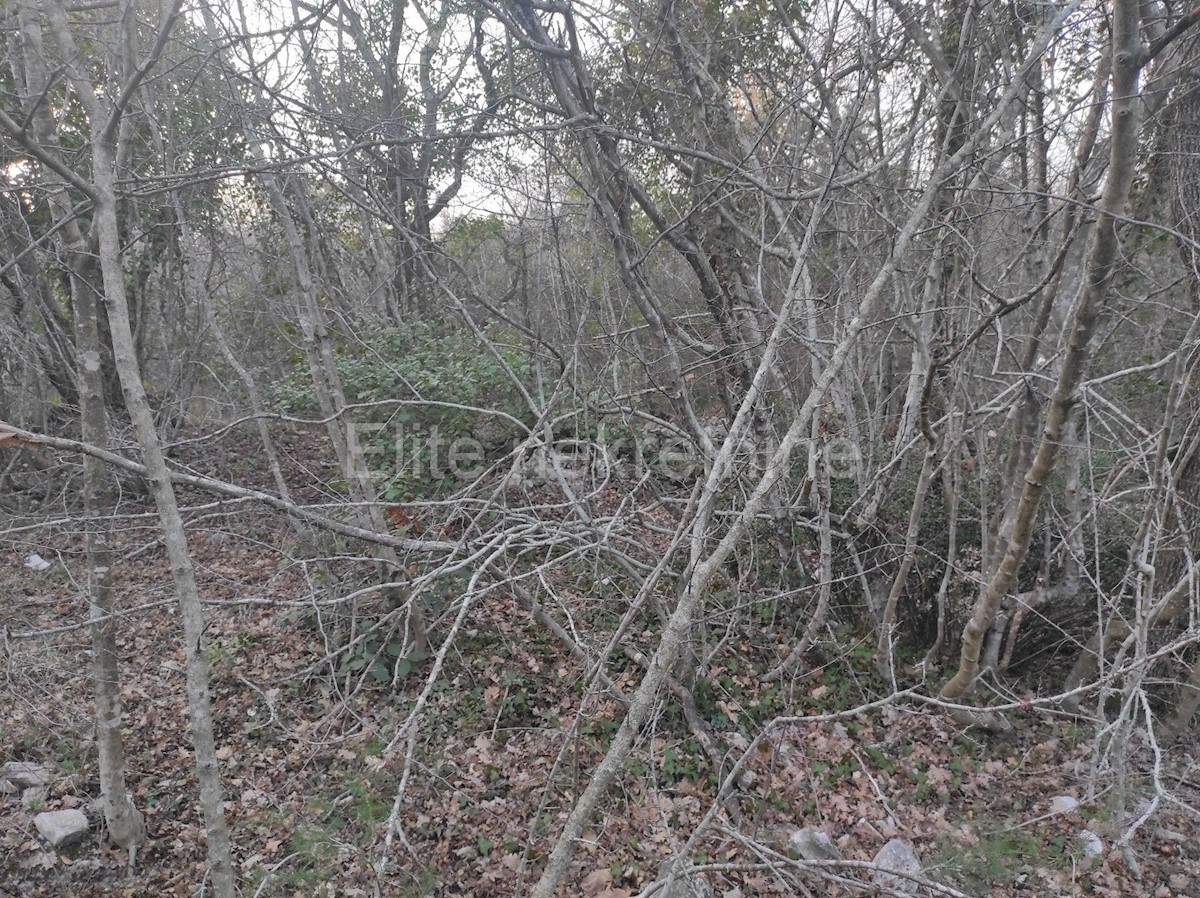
[0,0,1200,896]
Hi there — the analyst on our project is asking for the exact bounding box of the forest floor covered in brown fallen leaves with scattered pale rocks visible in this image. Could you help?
[0,422,1200,898]
